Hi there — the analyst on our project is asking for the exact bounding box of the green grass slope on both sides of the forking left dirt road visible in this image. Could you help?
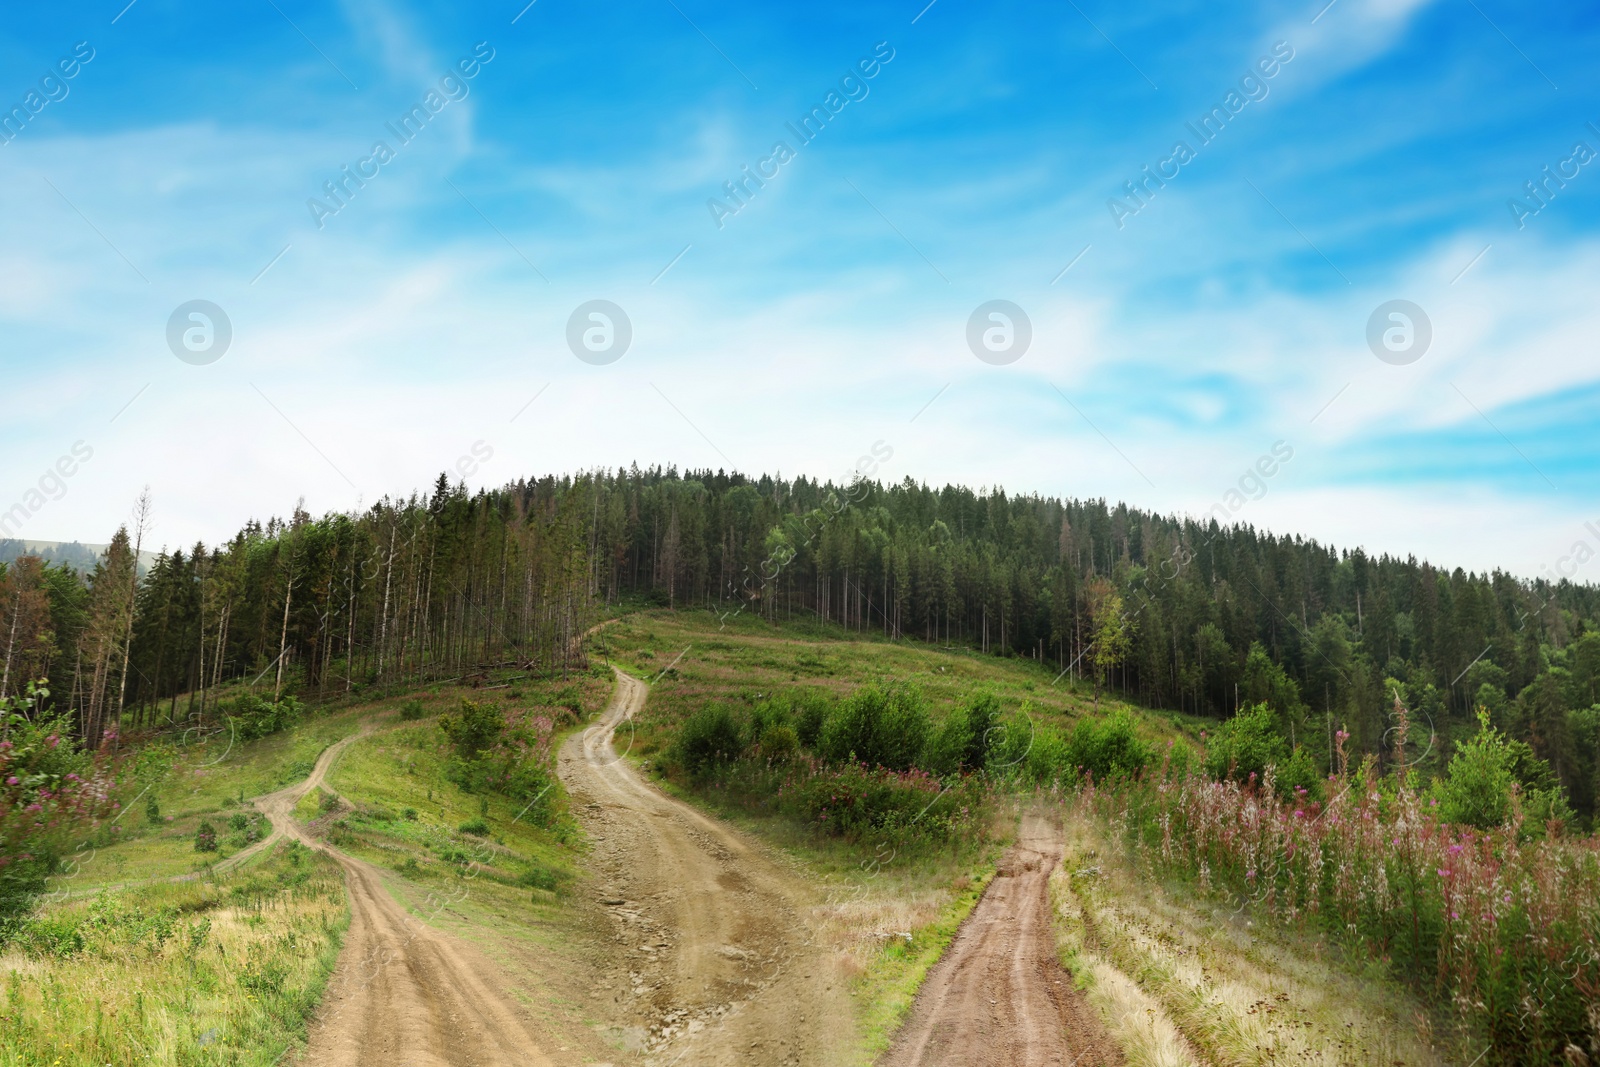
[0,670,613,1067]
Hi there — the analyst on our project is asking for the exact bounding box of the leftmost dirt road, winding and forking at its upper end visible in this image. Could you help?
[243,725,550,1067]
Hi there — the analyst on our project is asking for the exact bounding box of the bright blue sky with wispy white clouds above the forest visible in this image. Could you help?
[0,0,1600,581]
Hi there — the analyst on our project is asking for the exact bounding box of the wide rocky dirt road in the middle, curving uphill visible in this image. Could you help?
[560,672,854,1067]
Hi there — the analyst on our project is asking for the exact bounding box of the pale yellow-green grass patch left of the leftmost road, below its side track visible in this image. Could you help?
[0,845,349,1067]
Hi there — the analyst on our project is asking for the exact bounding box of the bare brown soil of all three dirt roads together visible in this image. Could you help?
[243,672,1123,1067]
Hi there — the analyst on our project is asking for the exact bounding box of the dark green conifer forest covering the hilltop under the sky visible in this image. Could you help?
[9,466,1600,825]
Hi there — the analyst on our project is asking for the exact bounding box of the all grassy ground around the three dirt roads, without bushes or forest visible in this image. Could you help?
[0,609,1465,1067]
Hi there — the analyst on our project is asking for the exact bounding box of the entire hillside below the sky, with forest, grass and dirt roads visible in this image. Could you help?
[0,470,1600,1065]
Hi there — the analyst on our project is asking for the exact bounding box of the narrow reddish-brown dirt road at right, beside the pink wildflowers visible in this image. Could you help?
[880,816,1123,1067]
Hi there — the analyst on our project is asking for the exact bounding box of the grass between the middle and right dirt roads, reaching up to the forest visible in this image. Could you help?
[590,609,1081,1064]
